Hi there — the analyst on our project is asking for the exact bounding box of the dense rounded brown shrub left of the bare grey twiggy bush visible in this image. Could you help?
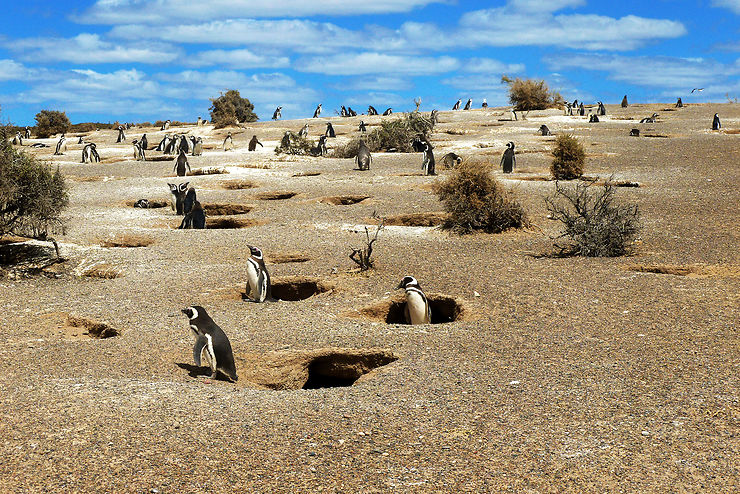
[435,162,528,235]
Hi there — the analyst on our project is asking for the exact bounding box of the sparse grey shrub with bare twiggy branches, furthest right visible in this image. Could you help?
[545,178,640,257]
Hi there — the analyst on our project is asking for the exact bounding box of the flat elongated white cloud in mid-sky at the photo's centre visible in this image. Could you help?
[294,52,460,75]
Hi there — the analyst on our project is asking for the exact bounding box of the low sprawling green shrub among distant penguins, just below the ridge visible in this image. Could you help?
[332,112,434,158]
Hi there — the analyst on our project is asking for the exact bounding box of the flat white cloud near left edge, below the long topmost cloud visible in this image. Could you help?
[5,33,181,64]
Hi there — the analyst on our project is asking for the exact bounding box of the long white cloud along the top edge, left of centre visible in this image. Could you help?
[75,0,440,24]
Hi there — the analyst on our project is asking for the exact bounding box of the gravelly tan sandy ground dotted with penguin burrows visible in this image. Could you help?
[0,105,740,492]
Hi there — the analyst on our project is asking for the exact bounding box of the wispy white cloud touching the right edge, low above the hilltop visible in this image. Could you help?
[546,54,740,92]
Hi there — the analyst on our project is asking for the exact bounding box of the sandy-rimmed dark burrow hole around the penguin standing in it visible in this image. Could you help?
[350,293,468,324]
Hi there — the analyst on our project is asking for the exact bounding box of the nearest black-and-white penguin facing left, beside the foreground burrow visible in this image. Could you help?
[182,305,239,382]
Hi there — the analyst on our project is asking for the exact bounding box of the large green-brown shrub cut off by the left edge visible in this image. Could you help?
[0,124,69,239]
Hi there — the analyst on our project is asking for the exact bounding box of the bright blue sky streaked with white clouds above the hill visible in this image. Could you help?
[0,0,740,125]
